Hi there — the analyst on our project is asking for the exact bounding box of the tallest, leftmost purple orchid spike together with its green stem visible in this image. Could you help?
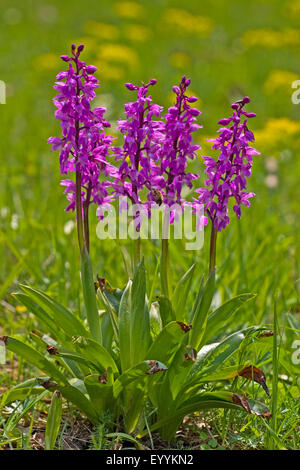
[48,44,117,341]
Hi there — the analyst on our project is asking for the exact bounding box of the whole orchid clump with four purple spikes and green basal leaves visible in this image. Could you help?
[0,44,270,441]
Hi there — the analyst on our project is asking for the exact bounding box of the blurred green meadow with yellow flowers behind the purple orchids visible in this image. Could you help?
[0,0,300,448]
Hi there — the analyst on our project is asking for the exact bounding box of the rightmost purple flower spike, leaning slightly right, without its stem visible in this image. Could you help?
[196,96,259,231]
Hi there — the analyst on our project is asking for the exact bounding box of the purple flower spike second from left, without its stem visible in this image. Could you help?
[112,79,163,208]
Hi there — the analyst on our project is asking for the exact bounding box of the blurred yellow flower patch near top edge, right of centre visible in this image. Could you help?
[163,8,214,37]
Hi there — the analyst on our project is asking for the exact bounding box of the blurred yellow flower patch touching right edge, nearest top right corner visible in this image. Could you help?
[242,28,300,49]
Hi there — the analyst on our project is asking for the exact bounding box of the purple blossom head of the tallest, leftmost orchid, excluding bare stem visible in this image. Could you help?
[48,44,117,217]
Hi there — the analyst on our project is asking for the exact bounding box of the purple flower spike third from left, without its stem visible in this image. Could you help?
[161,76,202,206]
